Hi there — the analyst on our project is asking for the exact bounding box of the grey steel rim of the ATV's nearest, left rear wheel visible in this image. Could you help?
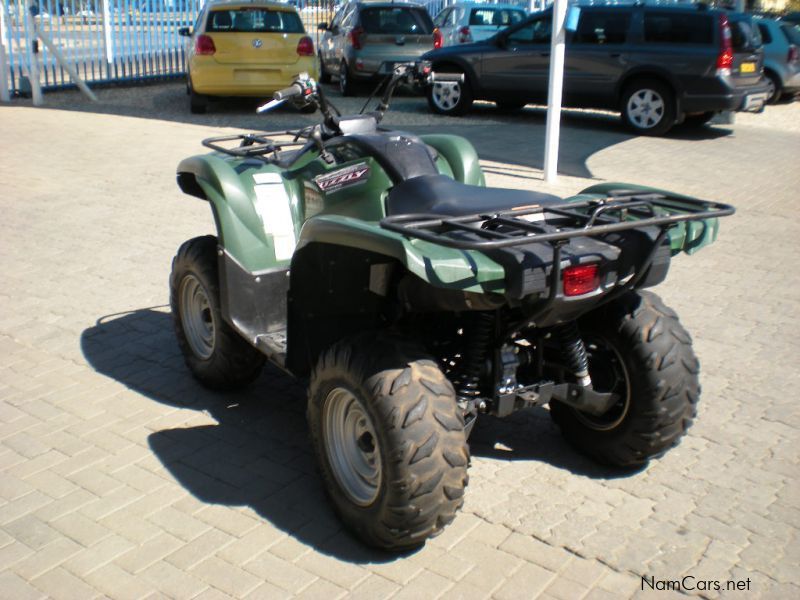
[322,387,383,506]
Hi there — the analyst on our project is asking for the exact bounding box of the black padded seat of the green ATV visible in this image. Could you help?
[386,175,563,217]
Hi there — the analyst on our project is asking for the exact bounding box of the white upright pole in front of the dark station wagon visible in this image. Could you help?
[544,0,567,183]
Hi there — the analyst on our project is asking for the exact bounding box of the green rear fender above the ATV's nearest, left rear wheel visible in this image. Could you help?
[297,215,505,294]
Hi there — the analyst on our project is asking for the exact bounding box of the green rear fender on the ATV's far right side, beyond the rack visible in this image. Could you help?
[567,182,719,256]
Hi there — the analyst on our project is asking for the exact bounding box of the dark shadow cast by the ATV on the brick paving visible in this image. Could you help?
[81,307,640,563]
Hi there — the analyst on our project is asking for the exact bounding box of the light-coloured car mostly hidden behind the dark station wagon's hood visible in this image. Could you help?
[433,2,527,46]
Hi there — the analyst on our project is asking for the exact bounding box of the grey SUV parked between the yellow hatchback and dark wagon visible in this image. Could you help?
[319,1,434,96]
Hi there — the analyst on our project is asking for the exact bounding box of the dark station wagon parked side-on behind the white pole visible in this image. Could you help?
[423,4,767,135]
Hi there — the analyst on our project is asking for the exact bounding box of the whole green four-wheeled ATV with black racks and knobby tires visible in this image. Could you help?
[170,64,734,550]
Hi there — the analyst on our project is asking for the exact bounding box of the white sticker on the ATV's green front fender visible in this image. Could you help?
[253,173,297,260]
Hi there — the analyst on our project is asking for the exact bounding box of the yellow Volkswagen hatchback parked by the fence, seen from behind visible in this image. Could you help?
[178,0,317,113]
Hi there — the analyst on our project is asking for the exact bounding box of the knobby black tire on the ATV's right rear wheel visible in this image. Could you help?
[550,292,700,467]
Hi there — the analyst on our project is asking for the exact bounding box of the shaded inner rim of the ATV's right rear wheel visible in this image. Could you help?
[572,335,631,431]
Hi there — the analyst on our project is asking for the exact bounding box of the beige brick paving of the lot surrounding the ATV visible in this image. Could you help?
[0,84,800,600]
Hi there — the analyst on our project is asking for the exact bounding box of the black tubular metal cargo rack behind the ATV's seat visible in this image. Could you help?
[380,189,735,250]
